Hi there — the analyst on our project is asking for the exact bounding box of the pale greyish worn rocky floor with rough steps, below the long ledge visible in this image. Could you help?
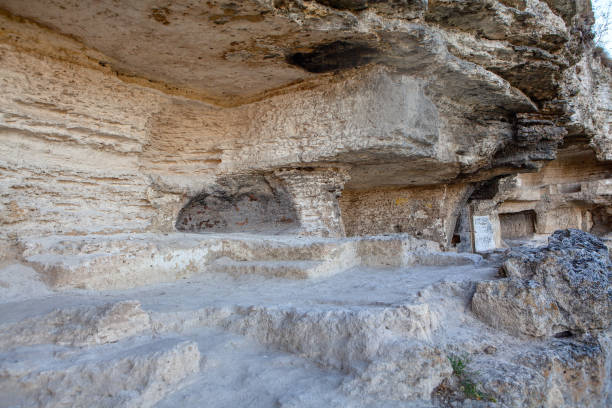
[0,233,611,407]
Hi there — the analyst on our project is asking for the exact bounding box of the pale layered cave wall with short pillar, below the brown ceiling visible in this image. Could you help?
[0,11,516,239]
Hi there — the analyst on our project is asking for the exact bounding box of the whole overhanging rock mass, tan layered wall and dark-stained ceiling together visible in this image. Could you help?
[0,0,610,246]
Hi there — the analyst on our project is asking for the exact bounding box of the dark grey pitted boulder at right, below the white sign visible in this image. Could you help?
[472,229,612,337]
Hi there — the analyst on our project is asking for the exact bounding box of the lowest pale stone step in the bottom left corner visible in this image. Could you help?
[0,338,200,408]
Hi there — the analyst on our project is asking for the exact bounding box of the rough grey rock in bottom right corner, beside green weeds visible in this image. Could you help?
[450,334,610,408]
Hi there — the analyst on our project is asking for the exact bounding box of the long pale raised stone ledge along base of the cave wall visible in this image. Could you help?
[20,233,480,290]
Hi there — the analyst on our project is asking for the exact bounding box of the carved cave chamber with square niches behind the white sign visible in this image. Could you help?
[464,143,612,251]
